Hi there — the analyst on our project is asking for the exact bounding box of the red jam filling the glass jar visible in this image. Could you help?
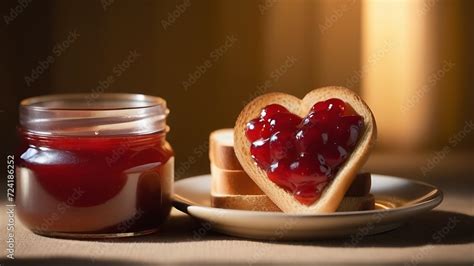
[16,132,173,235]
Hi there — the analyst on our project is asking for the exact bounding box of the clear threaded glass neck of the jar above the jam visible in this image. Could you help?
[20,93,169,136]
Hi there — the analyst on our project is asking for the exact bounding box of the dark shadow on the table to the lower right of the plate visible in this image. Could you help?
[281,210,474,248]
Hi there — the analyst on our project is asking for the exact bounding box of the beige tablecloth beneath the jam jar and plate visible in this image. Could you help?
[0,178,474,265]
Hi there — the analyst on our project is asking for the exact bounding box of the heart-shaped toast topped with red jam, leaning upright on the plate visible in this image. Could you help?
[234,87,377,214]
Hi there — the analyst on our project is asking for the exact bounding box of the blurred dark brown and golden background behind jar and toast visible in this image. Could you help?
[0,0,474,191]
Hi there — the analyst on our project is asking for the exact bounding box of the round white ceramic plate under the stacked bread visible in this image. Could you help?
[173,175,443,241]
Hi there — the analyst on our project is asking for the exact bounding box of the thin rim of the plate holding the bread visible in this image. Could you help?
[172,174,444,219]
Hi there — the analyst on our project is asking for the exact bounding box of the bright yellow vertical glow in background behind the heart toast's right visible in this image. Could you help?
[361,0,437,150]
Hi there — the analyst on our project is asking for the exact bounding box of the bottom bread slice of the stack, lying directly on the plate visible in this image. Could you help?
[211,194,375,212]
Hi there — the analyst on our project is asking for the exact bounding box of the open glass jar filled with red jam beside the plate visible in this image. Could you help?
[16,94,174,238]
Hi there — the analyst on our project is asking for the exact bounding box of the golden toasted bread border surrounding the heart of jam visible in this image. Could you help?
[234,87,377,214]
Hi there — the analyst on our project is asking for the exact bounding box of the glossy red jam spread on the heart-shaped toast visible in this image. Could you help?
[245,98,364,205]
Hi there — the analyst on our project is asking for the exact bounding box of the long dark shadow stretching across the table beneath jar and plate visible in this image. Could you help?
[39,210,474,248]
